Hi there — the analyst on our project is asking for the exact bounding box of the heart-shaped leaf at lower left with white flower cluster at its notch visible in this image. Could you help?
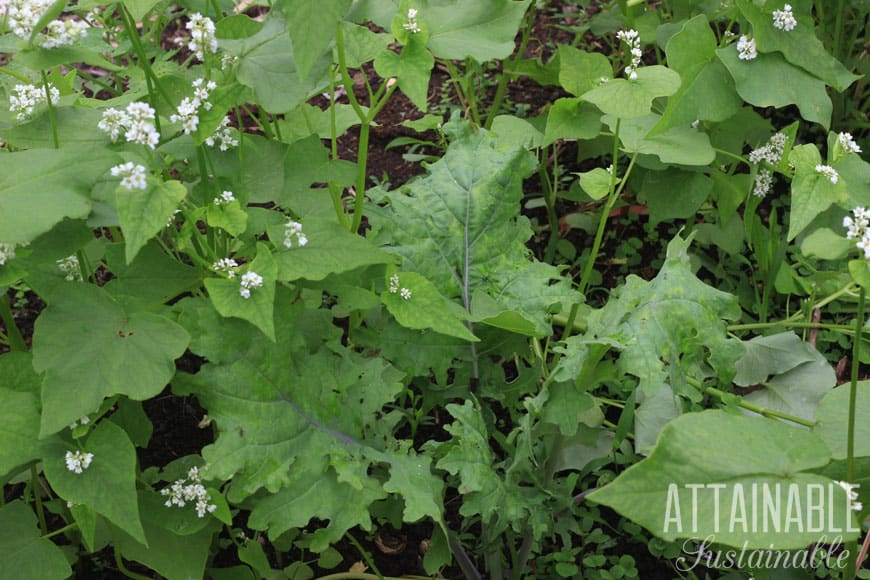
[42,421,145,544]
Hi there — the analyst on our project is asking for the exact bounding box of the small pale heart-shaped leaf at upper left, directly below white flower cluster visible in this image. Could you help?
[115,181,187,264]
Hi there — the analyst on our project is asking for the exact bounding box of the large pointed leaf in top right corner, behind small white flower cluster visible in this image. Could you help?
[737,0,861,93]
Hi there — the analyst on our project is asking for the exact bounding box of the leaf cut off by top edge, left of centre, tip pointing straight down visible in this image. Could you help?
[281,0,351,79]
